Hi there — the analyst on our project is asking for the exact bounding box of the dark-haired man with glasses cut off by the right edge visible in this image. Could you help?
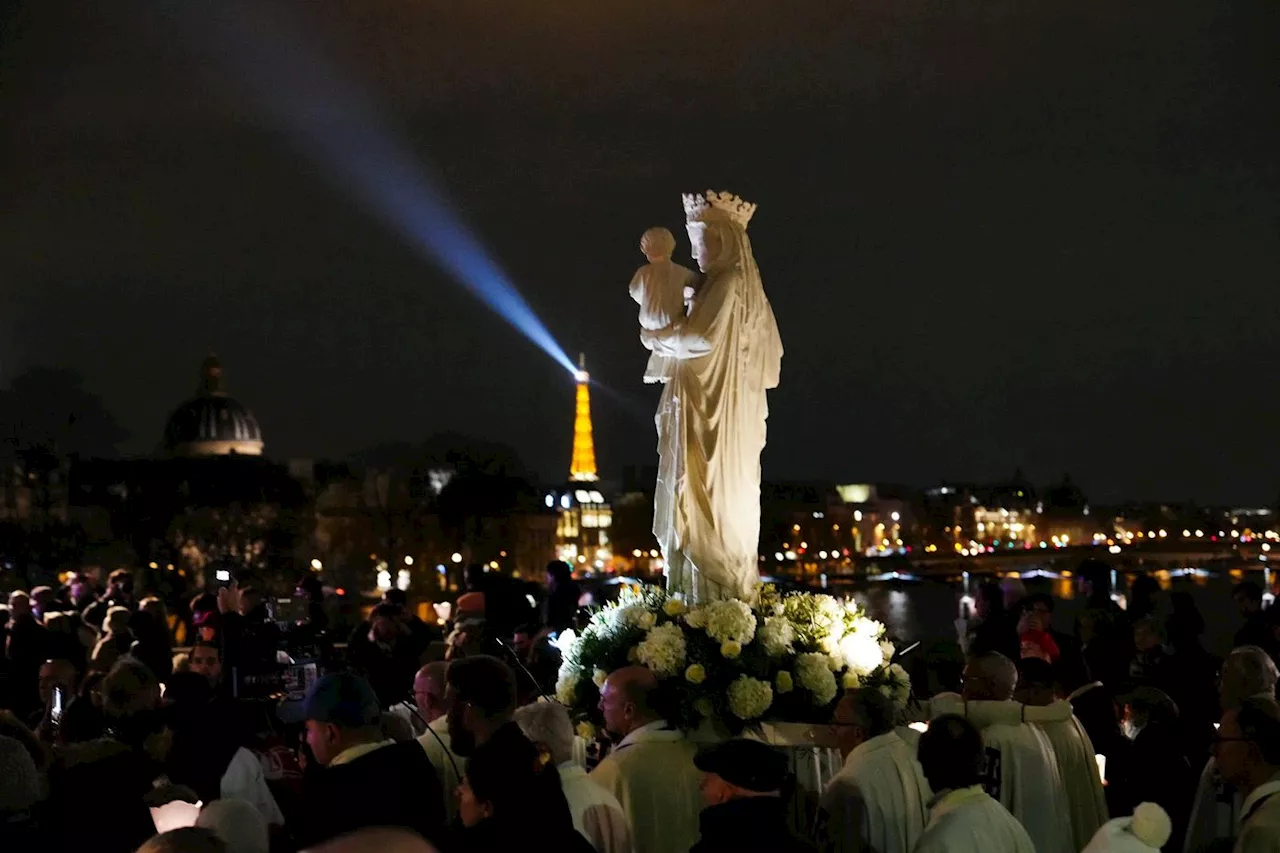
[1213,698,1280,853]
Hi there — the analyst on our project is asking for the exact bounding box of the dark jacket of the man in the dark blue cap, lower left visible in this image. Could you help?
[293,740,444,848]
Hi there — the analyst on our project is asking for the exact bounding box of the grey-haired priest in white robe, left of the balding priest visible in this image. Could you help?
[515,702,631,853]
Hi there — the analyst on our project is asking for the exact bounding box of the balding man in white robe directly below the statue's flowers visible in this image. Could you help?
[590,666,703,853]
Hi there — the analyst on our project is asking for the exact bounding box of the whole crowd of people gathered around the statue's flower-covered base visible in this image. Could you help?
[0,561,1280,853]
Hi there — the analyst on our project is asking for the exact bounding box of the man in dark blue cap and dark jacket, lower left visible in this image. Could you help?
[290,674,444,847]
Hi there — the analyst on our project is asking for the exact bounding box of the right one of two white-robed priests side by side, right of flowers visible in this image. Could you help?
[1008,658,1107,849]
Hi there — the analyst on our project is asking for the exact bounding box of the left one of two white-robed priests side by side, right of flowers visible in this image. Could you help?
[922,652,1076,853]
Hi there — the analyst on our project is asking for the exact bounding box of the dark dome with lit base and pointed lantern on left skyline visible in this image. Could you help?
[164,355,264,457]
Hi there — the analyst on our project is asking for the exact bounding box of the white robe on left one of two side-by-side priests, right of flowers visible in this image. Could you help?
[929,693,1076,853]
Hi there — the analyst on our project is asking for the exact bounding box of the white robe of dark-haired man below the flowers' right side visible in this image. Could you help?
[819,731,932,853]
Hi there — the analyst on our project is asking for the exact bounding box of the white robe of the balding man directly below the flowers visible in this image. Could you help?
[588,724,703,853]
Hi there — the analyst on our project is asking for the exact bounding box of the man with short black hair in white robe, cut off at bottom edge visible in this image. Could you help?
[914,715,1037,853]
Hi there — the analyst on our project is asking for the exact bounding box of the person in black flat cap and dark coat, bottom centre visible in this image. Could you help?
[689,738,817,853]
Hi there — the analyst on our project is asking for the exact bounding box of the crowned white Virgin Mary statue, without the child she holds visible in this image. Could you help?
[641,192,782,602]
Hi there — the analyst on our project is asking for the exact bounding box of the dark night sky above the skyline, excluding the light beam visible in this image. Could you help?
[0,0,1280,503]
